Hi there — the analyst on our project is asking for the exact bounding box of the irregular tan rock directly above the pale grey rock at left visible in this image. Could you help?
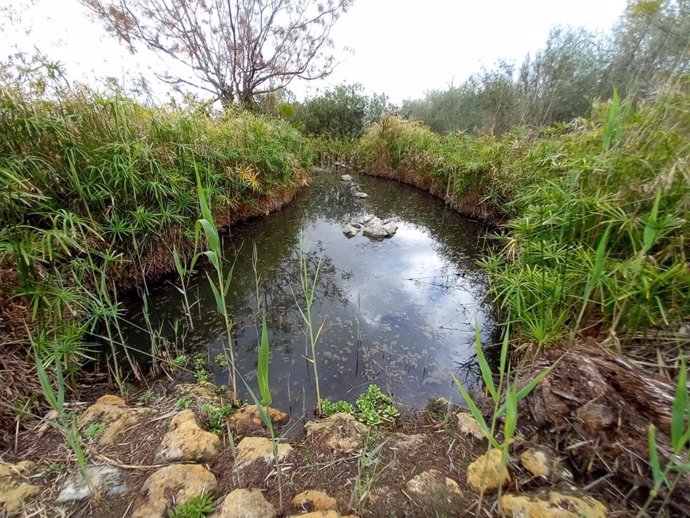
[79,395,156,446]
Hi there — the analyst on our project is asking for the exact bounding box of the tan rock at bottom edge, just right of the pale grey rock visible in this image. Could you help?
[132,464,218,518]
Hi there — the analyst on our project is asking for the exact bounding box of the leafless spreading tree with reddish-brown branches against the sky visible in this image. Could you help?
[80,0,354,106]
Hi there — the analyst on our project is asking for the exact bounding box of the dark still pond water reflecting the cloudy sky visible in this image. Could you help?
[121,173,494,424]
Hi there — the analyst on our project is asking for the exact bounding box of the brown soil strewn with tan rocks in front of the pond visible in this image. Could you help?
[0,383,626,518]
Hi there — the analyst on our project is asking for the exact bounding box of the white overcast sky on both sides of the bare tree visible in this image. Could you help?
[0,0,626,102]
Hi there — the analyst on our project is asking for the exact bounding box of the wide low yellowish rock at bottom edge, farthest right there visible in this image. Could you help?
[499,491,607,518]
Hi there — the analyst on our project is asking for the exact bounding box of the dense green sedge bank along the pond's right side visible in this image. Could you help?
[358,78,690,356]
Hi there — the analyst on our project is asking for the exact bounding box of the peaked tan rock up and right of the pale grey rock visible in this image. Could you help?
[155,410,220,463]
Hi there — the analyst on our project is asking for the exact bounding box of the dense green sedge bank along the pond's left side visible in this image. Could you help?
[0,84,311,426]
